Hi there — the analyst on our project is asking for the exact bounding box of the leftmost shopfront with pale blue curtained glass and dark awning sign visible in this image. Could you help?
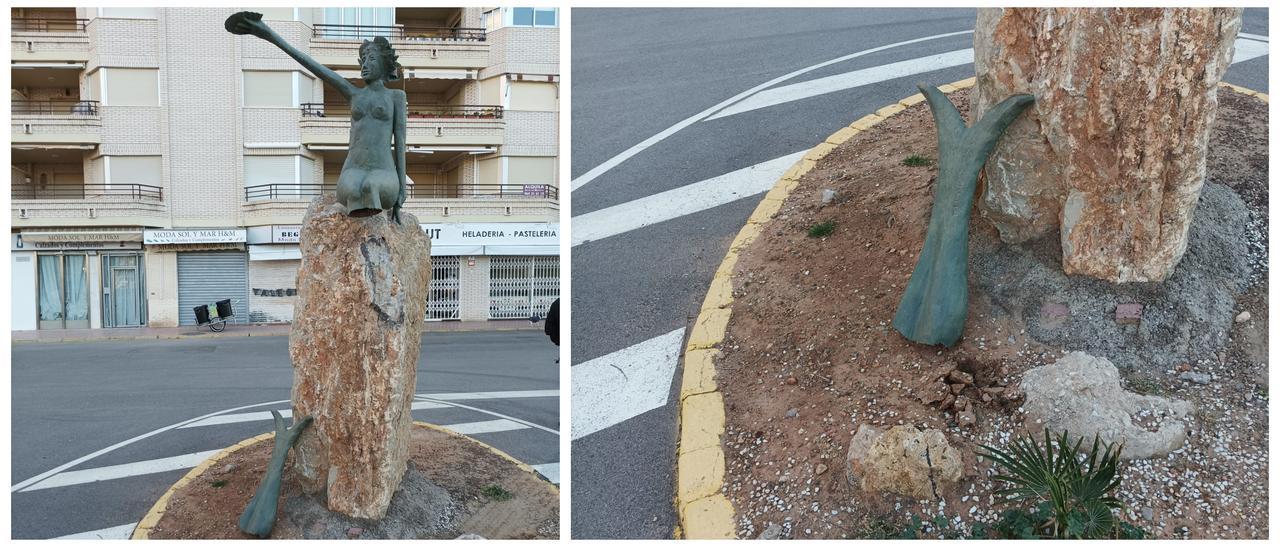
[10,230,147,330]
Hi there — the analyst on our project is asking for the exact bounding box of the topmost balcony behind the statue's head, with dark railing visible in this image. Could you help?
[311,23,489,70]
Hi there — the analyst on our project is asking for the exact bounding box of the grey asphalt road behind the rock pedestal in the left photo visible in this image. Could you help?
[12,330,561,538]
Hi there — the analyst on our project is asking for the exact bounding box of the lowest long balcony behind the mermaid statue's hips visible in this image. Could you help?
[244,183,559,225]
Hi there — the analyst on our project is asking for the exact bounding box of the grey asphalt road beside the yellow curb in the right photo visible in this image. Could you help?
[571,9,1267,538]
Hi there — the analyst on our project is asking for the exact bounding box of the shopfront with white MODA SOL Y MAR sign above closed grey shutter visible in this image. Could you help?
[145,228,250,325]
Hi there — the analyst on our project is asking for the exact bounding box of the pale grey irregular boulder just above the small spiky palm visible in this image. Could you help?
[1020,352,1192,458]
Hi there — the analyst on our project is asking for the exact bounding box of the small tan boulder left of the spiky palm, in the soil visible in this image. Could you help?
[845,424,961,501]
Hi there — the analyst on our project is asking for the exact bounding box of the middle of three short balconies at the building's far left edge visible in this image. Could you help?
[10,99,102,149]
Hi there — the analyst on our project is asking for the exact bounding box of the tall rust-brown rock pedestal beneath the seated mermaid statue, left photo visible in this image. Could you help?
[289,195,431,520]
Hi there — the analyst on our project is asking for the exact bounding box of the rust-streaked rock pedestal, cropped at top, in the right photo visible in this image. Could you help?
[972,8,1240,282]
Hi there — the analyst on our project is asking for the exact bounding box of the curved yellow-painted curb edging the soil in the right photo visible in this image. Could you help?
[676,78,974,539]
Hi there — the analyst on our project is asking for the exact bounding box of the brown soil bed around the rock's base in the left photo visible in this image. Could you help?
[151,426,559,539]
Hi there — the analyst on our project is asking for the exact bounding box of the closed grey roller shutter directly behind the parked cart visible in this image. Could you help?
[178,251,248,325]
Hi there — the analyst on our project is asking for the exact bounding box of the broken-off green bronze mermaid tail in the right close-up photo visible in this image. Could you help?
[893,83,1034,347]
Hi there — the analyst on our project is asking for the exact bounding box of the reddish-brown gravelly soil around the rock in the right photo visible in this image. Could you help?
[717,90,1268,538]
